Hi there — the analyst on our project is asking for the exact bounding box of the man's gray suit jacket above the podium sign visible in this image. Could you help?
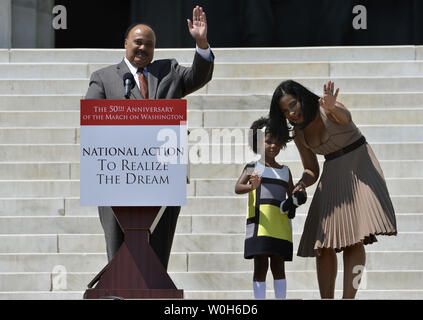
[85,52,214,99]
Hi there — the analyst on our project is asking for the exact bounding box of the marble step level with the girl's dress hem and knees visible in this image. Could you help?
[0,248,423,272]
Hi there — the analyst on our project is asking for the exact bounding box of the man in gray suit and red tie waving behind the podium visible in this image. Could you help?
[85,6,214,269]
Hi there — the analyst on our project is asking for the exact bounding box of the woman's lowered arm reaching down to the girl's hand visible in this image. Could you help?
[292,137,320,193]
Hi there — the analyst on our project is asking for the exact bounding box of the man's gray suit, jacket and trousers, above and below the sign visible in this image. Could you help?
[85,52,214,268]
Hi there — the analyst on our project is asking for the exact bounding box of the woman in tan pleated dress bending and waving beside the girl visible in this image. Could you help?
[270,80,397,299]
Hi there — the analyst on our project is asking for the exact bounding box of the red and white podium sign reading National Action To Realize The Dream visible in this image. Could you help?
[80,100,188,206]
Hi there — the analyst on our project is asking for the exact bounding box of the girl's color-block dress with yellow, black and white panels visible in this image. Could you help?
[244,161,293,261]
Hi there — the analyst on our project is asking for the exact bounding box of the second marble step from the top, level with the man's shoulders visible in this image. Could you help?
[0,61,423,79]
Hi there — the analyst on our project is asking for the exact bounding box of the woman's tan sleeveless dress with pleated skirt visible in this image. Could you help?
[295,108,397,257]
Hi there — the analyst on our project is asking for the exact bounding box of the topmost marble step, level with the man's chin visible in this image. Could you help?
[5,46,423,63]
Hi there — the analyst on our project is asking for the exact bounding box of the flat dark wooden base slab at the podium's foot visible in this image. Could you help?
[84,288,184,299]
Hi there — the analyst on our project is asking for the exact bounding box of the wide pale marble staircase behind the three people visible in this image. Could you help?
[0,46,423,299]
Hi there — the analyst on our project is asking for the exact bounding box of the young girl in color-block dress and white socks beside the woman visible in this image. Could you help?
[235,118,305,299]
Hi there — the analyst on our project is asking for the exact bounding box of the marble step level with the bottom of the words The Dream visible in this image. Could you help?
[0,176,423,198]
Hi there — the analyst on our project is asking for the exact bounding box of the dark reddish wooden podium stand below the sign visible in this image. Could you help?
[84,207,183,299]
